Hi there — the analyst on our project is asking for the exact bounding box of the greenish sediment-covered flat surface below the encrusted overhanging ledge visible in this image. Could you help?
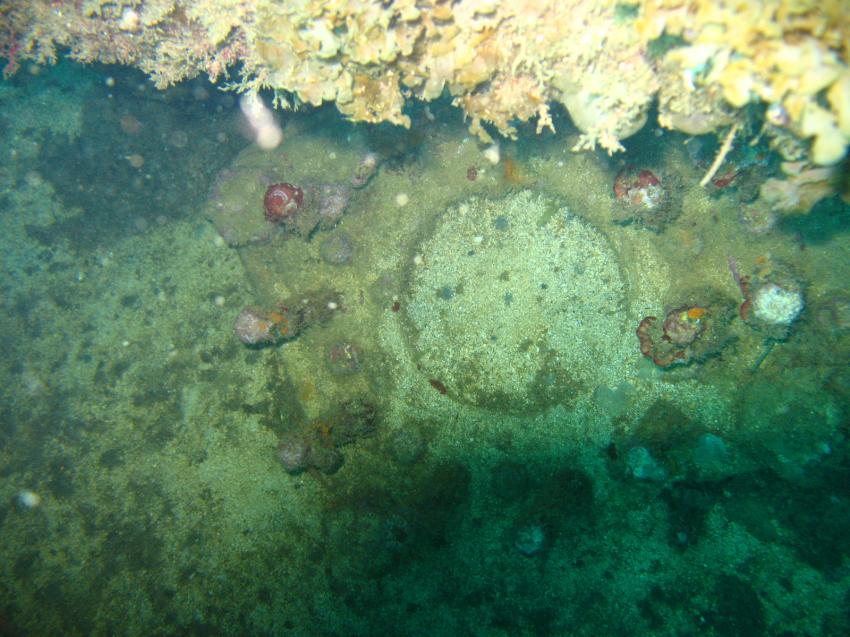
[0,63,850,636]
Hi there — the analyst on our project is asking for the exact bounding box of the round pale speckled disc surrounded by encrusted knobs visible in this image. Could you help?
[405,191,625,413]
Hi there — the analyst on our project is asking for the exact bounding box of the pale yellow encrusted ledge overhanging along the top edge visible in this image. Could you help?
[0,0,850,171]
